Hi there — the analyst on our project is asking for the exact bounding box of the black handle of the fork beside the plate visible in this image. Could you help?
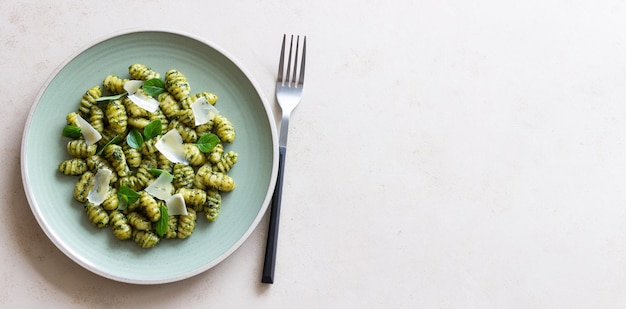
[261,146,287,283]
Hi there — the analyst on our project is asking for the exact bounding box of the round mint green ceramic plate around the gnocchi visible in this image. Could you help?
[21,30,278,284]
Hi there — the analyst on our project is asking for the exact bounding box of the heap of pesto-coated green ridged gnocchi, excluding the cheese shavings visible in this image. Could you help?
[57,63,238,248]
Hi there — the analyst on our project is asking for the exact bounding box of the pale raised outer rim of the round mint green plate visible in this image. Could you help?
[20,27,279,285]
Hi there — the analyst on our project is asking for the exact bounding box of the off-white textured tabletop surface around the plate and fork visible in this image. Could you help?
[0,0,626,308]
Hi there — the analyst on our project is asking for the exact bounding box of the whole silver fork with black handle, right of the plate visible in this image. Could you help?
[261,34,306,283]
